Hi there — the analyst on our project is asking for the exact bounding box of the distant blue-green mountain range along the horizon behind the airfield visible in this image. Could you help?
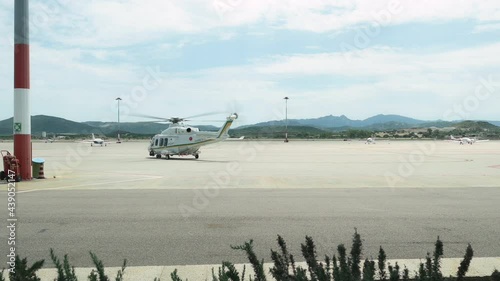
[0,114,500,135]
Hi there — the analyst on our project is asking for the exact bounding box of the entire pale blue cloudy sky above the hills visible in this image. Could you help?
[0,0,500,125]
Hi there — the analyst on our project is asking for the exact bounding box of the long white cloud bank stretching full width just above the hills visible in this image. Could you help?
[5,40,500,124]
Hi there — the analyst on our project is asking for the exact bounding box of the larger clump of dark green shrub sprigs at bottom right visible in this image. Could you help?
[171,230,478,281]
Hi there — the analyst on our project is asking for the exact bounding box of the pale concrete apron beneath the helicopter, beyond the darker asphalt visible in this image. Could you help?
[4,141,500,191]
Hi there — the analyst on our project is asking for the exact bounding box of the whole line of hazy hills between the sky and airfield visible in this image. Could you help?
[0,114,500,138]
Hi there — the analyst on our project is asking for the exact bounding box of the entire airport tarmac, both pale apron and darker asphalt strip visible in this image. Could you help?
[0,140,500,272]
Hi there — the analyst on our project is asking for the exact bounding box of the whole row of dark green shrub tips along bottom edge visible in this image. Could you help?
[0,231,492,281]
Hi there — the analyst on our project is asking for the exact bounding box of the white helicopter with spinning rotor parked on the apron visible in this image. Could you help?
[142,113,238,159]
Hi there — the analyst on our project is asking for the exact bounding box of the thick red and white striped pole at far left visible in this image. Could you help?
[14,0,31,180]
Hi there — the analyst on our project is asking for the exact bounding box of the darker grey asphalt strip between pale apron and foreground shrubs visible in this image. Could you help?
[0,187,500,266]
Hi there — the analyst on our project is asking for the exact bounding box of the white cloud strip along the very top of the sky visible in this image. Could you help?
[16,0,500,47]
